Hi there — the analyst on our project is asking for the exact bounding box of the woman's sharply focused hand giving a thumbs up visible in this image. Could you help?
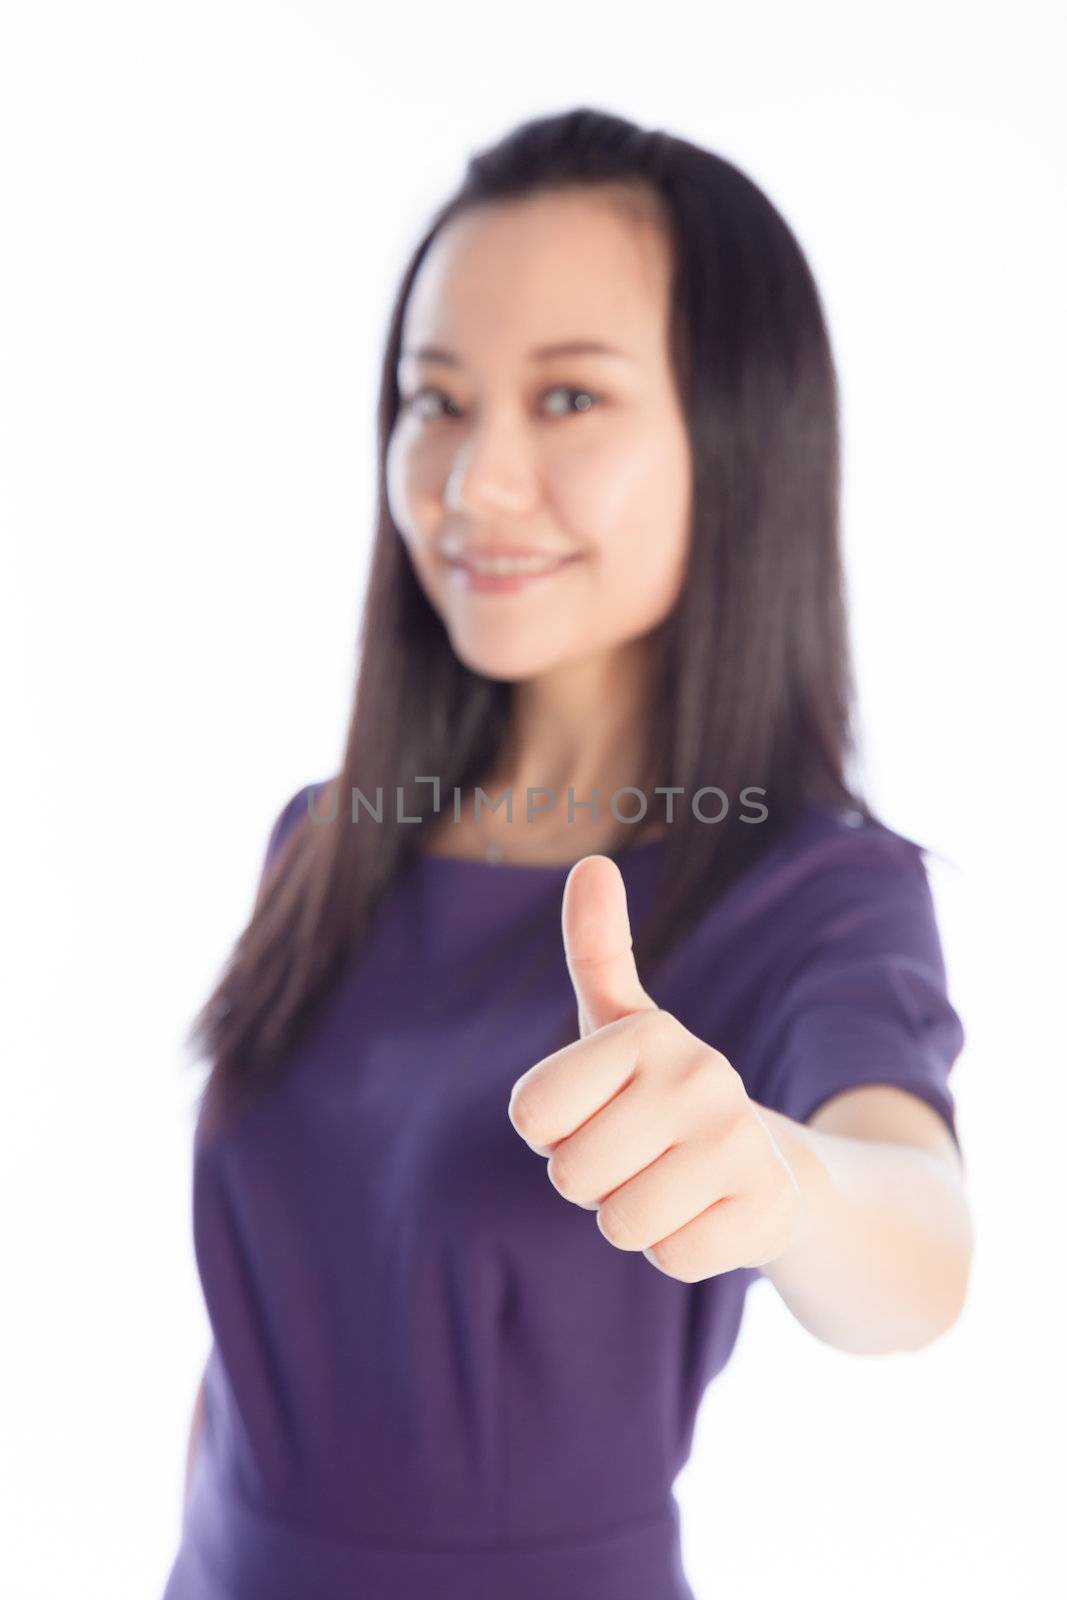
[507,856,801,1283]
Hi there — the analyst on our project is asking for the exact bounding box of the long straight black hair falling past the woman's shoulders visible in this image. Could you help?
[189,107,877,1139]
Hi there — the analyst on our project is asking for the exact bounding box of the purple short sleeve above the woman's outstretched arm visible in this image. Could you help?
[755,834,965,1154]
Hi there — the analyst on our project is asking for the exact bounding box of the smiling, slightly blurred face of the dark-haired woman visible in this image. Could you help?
[387,190,691,682]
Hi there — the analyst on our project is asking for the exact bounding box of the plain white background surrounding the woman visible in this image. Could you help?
[0,0,1067,1600]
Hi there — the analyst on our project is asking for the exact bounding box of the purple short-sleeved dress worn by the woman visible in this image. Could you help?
[165,784,963,1600]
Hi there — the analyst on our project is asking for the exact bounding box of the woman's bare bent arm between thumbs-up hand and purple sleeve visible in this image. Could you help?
[760,1106,971,1355]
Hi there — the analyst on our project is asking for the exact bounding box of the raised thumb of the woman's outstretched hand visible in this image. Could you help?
[563,856,659,1038]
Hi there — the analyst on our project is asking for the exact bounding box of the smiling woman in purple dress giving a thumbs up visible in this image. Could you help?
[166,109,969,1600]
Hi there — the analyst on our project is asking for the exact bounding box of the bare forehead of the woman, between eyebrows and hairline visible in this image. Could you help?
[396,187,670,360]
